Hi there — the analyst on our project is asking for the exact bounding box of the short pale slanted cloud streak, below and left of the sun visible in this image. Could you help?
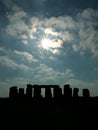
[14,50,37,62]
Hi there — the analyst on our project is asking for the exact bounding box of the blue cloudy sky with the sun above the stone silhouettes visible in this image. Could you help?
[0,0,98,97]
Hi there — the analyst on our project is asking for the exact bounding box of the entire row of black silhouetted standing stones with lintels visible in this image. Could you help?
[9,84,90,102]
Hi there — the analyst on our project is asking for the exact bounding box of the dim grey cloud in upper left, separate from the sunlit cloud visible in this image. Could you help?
[6,9,29,37]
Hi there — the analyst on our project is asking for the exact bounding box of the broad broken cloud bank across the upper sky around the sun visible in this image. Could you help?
[6,5,98,57]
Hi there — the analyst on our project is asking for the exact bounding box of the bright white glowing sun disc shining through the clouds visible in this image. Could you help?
[41,38,53,50]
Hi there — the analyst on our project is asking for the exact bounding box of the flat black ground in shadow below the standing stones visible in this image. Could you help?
[0,98,98,130]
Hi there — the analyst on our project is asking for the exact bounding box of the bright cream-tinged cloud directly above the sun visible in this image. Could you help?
[30,16,76,40]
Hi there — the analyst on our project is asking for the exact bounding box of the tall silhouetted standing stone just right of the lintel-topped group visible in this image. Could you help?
[64,84,72,98]
